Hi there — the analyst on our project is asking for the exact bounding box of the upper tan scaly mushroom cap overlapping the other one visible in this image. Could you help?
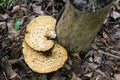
[25,16,56,51]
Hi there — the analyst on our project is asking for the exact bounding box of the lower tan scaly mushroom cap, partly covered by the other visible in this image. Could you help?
[23,41,67,73]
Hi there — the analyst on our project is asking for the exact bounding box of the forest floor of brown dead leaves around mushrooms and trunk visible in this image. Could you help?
[0,0,120,80]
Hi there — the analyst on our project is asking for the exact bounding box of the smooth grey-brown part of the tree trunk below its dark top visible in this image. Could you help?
[56,0,111,52]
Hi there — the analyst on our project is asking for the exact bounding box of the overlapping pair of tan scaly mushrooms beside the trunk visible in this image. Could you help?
[22,16,67,73]
